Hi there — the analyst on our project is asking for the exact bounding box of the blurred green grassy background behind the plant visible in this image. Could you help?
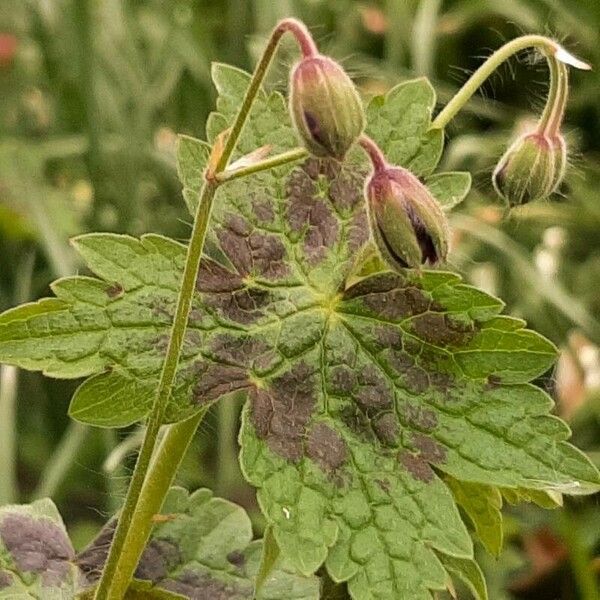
[0,0,600,600]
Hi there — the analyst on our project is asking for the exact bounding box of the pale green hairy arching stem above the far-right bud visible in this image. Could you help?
[431,35,560,129]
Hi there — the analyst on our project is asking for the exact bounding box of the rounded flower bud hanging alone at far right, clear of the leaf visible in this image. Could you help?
[492,131,567,206]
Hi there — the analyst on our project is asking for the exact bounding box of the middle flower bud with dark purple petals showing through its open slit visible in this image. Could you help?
[366,166,449,268]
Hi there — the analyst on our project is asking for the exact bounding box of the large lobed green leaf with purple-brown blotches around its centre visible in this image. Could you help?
[0,65,600,600]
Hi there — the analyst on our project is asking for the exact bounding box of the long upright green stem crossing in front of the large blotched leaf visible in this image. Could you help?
[94,19,310,600]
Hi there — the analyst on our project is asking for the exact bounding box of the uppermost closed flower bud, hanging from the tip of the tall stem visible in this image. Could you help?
[290,54,365,159]
